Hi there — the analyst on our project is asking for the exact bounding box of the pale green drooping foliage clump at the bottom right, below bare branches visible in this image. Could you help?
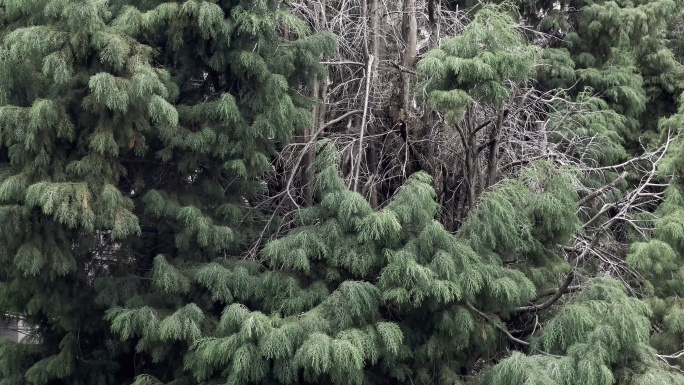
[487,278,656,385]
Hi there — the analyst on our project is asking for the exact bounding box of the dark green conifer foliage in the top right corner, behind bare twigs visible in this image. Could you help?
[536,0,684,140]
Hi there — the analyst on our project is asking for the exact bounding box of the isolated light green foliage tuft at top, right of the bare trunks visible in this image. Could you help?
[417,4,537,124]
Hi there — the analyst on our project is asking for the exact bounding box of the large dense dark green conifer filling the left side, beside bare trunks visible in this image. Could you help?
[0,0,335,384]
